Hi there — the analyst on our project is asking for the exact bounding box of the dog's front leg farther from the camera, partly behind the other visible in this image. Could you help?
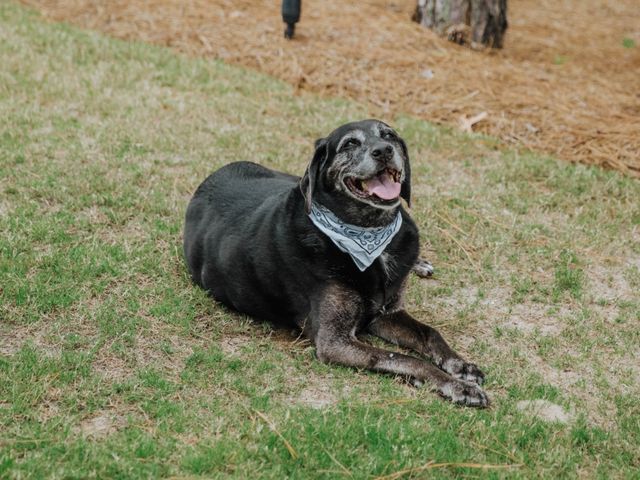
[367,310,484,385]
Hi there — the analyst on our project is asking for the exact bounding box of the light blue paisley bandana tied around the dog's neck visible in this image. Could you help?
[309,202,402,272]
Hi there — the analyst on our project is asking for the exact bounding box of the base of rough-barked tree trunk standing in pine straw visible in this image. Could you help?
[412,0,507,48]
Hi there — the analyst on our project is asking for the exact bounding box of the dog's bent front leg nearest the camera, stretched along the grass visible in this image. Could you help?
[312,286,489,407]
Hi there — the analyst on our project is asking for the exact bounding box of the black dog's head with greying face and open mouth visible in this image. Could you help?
[300,120,411,224]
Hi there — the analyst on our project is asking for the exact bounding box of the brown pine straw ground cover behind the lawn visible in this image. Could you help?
[22,0,640,177]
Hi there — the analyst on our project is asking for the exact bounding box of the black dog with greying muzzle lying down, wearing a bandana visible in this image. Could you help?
[184,120,489,407]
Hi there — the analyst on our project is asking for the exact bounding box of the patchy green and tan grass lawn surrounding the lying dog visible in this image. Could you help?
[0,2,640,478]
